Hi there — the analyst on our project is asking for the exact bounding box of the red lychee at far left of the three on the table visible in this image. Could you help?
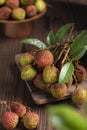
[1,111,19,130]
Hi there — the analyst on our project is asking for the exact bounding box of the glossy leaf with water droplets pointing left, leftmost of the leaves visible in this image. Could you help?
[21,39,47,49]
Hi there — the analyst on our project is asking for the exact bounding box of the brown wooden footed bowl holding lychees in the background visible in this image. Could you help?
[0,9,46,38]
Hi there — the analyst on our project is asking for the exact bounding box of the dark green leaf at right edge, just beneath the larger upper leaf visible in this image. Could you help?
[71,46,87,60]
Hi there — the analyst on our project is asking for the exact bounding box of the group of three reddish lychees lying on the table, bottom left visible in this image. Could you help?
[1,102,39,130]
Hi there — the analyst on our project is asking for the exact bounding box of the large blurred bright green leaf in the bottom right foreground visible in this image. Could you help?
[47,104,87,130]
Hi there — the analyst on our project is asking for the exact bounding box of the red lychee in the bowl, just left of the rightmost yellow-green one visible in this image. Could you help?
[25,5,37,17]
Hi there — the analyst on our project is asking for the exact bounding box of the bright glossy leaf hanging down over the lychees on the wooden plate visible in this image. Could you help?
[58,62,74,84]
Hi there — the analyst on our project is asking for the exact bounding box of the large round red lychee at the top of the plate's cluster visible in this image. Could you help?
[35,49,54,67]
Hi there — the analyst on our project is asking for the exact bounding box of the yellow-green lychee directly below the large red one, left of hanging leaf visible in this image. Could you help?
[43,66,59,84]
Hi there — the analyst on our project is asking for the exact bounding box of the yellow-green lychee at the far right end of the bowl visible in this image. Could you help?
[35,0,46,13]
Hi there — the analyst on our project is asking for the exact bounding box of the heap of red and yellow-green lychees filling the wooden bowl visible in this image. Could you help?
[0,0,46,20]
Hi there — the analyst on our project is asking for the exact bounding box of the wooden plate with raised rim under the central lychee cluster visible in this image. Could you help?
[15,53,87,105]
